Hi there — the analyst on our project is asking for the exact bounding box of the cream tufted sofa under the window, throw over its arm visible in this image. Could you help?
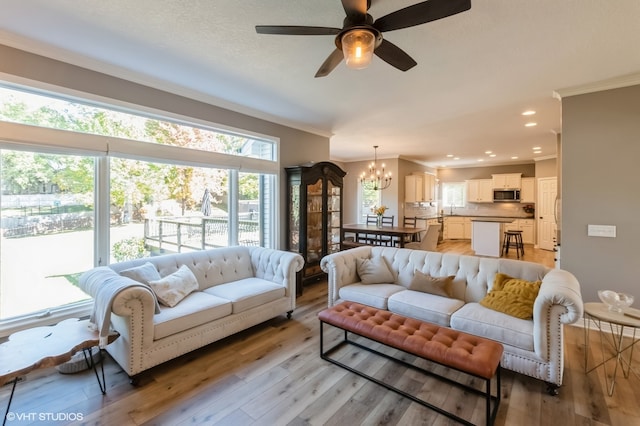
[80,247,304,381]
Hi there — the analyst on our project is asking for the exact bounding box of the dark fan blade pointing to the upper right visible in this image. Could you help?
[373,0,471,32]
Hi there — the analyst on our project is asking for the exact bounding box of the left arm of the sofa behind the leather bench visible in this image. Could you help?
[320,246,371,307]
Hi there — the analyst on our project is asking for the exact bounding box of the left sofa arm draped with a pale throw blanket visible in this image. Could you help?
[78,266,157,347]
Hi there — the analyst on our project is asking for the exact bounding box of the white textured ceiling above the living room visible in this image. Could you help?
[0,0,640,166]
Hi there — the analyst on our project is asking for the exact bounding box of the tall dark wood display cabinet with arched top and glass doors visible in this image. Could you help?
[286,161,346,294]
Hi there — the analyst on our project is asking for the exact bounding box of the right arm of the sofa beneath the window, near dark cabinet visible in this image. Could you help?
[251,247,304,300]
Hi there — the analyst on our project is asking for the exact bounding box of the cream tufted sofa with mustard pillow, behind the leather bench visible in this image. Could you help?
[320,246,583,394]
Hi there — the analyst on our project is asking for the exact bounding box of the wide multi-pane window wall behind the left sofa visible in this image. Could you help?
[0,83,279,330]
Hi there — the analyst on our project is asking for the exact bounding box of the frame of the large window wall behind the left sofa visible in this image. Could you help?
[0,82,280,338]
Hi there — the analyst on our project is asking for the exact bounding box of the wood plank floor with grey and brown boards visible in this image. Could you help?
[0,243,640,426]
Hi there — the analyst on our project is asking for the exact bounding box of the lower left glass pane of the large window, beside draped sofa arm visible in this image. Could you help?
[0,150,94,321]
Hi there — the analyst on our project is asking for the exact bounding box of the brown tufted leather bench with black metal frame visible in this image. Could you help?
[318,302,503,425]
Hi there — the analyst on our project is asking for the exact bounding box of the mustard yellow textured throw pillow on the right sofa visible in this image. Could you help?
[480,273,542,319]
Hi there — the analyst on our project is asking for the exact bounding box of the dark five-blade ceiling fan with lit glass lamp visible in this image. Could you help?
[256,0,471,77]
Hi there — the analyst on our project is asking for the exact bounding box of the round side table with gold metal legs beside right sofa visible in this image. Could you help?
[584,303,640,396]
